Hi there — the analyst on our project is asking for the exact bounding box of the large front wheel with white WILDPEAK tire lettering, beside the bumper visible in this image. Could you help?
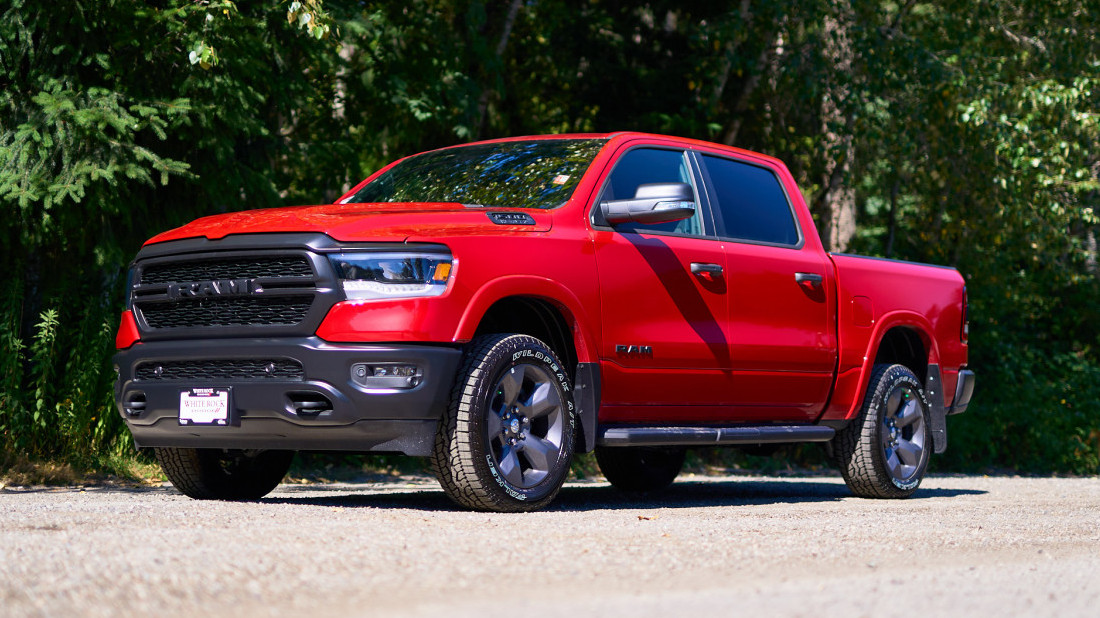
[431,334,575,512]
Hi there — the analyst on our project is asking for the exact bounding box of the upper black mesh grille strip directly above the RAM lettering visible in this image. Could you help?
[141,255,314,285]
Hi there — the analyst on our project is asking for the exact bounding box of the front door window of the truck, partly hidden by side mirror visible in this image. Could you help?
[597,148,703,236]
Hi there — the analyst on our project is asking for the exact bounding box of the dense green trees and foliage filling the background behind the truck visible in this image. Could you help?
[0,0,1100,473]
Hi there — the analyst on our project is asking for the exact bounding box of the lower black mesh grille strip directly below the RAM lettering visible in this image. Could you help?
[140,296,314,329]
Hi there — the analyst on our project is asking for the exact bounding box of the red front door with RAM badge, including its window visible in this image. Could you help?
[593,145,732,422]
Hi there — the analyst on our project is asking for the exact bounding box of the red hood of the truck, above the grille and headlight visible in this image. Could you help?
[145,202,553,244]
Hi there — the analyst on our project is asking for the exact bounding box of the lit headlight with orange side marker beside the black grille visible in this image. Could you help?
[329,248,452,300]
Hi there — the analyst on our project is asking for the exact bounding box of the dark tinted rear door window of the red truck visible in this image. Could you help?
[702,155,799,244]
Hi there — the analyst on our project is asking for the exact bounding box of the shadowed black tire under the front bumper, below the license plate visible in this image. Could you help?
[154,448,294,500]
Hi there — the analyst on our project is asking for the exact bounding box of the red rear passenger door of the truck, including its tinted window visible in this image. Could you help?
[694,153,837,421]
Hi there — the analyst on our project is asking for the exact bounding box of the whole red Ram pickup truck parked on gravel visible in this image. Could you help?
[114,133,975,511]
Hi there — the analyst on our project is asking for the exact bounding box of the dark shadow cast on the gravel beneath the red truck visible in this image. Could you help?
[261,481,986,512]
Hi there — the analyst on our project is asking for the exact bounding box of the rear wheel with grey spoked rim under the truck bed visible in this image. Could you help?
[833,365,932,498]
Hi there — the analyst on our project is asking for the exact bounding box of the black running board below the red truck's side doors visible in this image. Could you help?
[596,424,836,446]
